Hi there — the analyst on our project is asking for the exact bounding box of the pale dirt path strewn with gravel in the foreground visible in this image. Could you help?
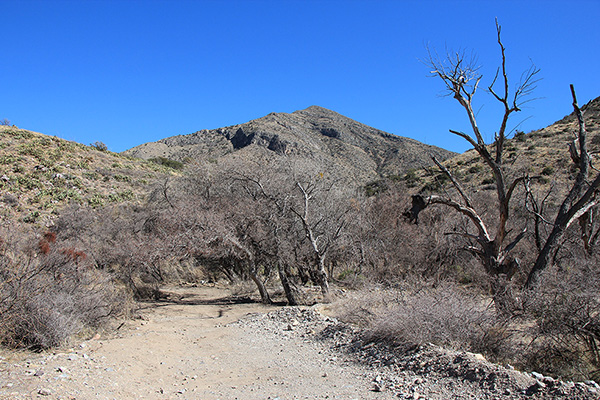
[0,287,397,400]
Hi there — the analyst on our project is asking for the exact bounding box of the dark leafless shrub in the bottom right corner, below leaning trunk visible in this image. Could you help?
[523,259,600,380]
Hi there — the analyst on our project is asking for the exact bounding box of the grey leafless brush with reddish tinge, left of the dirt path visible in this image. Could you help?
[0,231,128,349]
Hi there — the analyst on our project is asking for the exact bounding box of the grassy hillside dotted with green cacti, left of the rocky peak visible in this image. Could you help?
[0,126,176,225]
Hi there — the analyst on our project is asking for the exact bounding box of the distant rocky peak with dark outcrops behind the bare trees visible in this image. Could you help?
[124,106,456,188]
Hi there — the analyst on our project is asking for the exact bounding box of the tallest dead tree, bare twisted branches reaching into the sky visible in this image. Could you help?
[418,21,539,311]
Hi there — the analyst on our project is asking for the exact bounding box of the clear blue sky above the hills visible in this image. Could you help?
[0,0,600,151]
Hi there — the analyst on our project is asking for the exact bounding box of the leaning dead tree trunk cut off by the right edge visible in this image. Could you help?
[525,85,600,287]
